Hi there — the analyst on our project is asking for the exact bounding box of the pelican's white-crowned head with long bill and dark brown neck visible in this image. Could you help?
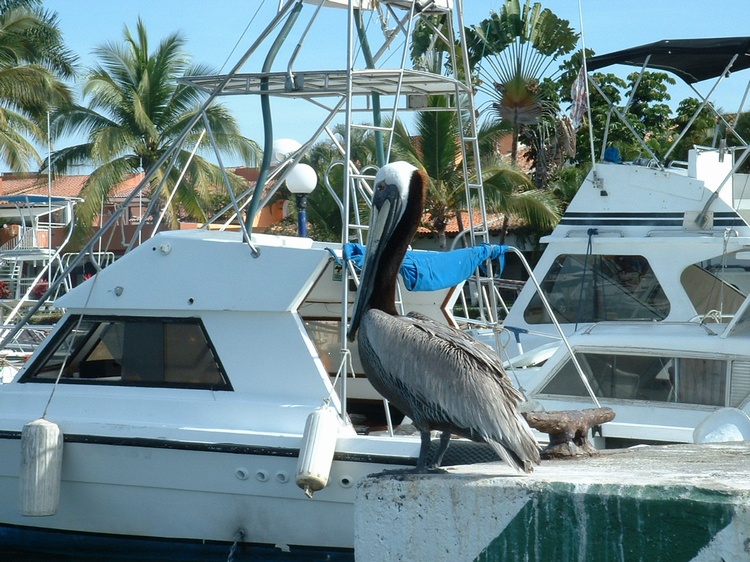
[348,162,427,340]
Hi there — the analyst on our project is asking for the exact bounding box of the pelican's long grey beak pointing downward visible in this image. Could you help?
[348,178,405,341]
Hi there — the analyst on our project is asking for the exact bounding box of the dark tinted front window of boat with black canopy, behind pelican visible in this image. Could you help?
[524,255,669,324]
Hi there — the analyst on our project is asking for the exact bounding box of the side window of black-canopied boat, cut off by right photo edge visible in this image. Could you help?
[680,252,750,322]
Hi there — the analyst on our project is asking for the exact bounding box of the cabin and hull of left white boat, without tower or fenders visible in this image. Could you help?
[0,230,458,554]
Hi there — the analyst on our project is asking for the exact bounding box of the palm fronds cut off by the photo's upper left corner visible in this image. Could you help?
[0,0,76,171]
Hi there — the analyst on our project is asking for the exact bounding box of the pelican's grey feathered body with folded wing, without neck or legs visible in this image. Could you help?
[358,308,539,472]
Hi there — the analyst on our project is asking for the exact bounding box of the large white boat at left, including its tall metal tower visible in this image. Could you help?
[0,0,494,560]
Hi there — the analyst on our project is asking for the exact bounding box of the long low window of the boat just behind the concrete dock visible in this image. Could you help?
[541,353,727,406]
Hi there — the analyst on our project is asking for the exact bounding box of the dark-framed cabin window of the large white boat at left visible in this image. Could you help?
[21,317,231,390]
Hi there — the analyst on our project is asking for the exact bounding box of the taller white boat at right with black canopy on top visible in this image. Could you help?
[488,37,750,357]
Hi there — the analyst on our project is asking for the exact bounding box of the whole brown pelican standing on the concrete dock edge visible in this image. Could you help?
[348,162,539,472]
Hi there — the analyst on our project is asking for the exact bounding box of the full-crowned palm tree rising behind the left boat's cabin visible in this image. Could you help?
[51,19,259,229]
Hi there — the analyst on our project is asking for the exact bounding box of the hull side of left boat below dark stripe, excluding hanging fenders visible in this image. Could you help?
[0,433,417,559]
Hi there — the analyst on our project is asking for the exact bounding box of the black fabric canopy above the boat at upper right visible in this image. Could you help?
[586,37,750,84]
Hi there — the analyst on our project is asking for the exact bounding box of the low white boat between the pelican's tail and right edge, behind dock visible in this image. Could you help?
[509,310,750,448]
